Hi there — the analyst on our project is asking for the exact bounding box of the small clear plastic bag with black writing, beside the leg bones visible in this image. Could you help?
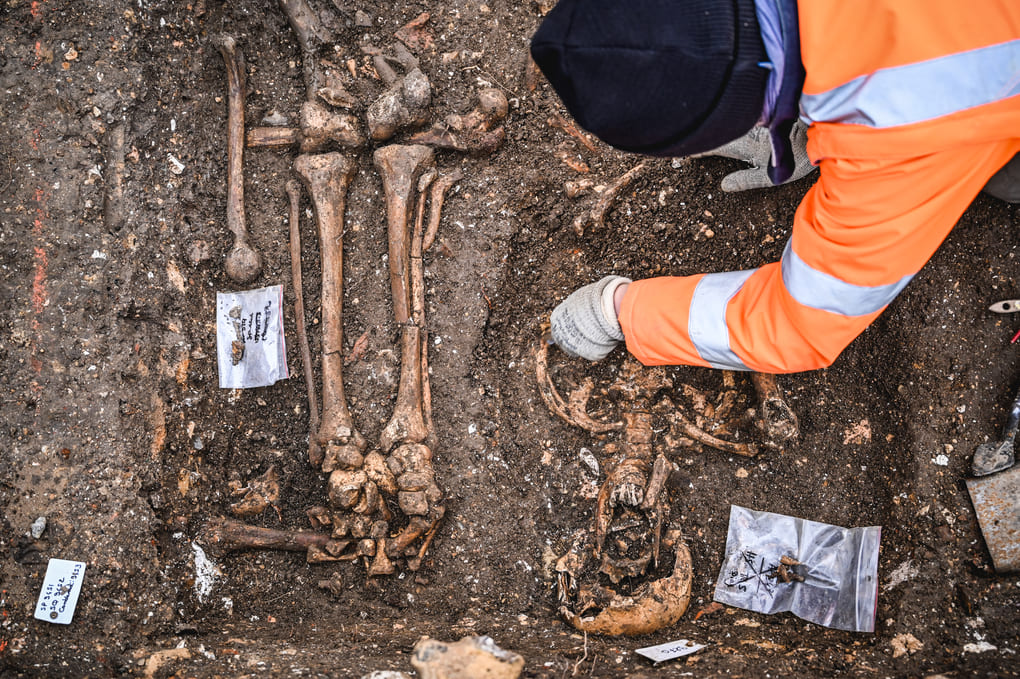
[216,285,288,389]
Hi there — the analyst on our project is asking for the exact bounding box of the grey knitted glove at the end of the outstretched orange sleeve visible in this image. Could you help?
[550,276,630,361]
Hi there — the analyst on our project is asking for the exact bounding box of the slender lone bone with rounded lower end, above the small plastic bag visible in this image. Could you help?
[215,35,262,285]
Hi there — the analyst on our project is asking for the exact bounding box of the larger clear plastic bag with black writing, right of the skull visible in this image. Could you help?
[715,505,881,632]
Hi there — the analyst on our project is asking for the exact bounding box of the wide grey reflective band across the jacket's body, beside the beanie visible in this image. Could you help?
[801,40,1020,127]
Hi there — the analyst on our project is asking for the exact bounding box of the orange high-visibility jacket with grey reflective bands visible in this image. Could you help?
[619,0,1020,372]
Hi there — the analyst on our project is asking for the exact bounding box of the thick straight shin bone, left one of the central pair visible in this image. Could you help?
[294,153,365,471]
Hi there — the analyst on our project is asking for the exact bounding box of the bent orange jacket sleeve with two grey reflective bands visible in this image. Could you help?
[619,141,1020,372]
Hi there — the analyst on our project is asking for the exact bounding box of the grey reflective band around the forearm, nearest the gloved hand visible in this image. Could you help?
[687,269,757,370]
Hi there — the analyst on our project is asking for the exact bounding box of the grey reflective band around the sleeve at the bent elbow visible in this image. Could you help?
[781,241,914,316]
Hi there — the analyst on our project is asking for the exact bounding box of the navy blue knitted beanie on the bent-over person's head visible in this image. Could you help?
[531,0,768,156]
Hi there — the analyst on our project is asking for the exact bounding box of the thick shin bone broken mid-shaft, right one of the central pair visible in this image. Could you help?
[373,145,435,453]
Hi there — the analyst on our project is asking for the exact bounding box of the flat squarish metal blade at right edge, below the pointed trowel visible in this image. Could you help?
[967,466,1020,573]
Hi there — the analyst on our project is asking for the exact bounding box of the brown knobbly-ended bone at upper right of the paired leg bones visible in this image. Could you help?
[410,88,508,154]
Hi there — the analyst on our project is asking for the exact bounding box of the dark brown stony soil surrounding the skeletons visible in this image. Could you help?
[0,0,1020,678]
